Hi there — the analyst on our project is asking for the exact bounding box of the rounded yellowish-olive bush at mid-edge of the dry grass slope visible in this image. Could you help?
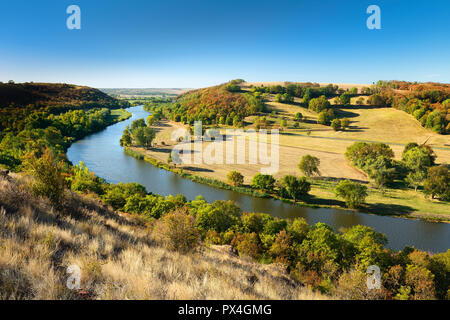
[153,209,200,253]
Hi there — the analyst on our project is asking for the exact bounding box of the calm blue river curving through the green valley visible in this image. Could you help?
[67,106,450,252]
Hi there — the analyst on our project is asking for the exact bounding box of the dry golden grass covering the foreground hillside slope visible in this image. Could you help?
[0,176,325,299]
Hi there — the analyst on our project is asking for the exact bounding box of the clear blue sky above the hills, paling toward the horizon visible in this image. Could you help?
[0,0,450,88]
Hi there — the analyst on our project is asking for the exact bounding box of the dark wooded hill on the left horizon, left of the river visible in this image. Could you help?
[0,82,121,109]
